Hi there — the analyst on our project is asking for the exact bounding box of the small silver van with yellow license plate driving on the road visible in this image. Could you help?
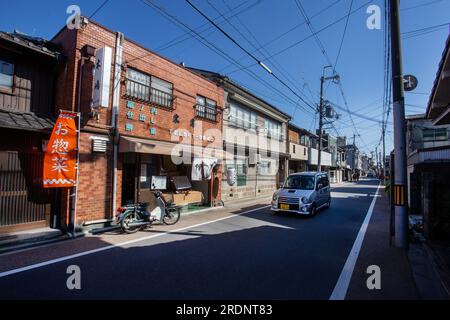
[271,171,331,216]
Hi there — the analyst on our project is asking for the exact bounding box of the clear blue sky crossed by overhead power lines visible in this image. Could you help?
[0,0,450,153]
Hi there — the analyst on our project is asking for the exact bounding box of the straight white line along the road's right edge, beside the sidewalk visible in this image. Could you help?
[330,185,380,300]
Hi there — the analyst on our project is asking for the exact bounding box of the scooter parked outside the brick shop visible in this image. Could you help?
[117,191,181,233]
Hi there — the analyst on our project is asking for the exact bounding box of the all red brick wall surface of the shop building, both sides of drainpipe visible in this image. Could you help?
[53,21,224,224]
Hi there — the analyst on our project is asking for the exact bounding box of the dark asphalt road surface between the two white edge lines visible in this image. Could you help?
[0,180,378,299]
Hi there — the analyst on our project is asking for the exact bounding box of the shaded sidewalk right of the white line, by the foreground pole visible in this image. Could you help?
[346,188,446,300]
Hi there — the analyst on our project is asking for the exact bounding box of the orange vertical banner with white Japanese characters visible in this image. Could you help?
[43,111,78,188]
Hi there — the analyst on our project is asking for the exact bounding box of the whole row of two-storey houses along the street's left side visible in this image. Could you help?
[0,19,362,233]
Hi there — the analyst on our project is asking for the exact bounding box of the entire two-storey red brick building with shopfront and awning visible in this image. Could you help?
[52,19,224,231]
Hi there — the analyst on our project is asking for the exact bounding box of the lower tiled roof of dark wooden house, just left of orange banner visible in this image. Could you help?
[0,109,55,131]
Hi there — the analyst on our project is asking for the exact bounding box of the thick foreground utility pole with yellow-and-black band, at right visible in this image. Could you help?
[389,0,408,249]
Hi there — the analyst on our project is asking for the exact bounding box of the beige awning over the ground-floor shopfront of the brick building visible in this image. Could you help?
[119,136,233,160]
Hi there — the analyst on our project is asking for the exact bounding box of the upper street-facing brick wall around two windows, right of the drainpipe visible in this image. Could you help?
[118,37,224,147]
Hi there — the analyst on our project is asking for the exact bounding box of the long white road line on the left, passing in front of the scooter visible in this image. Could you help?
[0,206,270,278]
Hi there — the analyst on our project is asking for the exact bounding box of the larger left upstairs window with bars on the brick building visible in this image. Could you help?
[127,69,173,108]
